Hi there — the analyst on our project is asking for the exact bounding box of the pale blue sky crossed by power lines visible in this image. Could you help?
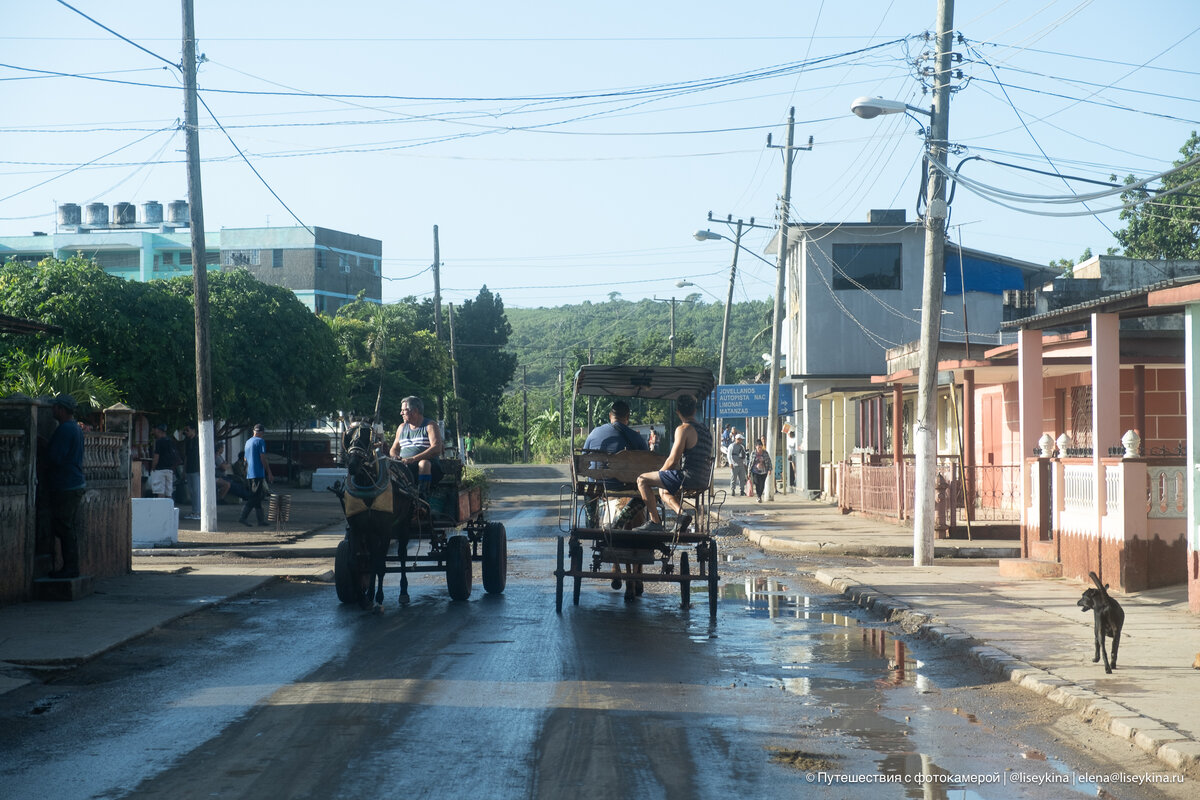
[0,0,1200,307]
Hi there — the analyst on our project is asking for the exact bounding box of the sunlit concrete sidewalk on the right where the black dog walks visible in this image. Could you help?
[719,474,1200,775]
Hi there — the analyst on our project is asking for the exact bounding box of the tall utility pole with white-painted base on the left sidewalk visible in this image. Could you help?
[182,0,217,533]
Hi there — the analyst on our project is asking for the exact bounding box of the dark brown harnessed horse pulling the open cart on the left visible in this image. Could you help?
[338,422,416,610]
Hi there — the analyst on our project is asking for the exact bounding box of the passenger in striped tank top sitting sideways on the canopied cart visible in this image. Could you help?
[634,395,713,533]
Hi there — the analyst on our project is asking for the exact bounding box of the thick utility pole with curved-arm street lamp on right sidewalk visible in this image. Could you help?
[912,0,954,566]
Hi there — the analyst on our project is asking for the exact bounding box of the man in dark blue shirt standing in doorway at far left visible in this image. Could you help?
[46,395,88,578]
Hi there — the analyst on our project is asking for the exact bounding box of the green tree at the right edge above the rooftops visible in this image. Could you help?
[1116,131,1200,259]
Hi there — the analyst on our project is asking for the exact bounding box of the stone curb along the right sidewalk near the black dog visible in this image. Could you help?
[814,570,1200,771]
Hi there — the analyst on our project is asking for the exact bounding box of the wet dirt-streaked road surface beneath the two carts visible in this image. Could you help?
[0,469,1193,800]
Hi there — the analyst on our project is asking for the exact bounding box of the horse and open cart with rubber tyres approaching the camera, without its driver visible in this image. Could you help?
[330,425,508,607]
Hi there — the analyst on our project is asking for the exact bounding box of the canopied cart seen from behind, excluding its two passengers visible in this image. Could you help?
[554,365,724,619]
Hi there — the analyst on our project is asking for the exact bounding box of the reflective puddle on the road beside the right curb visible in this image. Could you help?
[705,577,1097,800]
